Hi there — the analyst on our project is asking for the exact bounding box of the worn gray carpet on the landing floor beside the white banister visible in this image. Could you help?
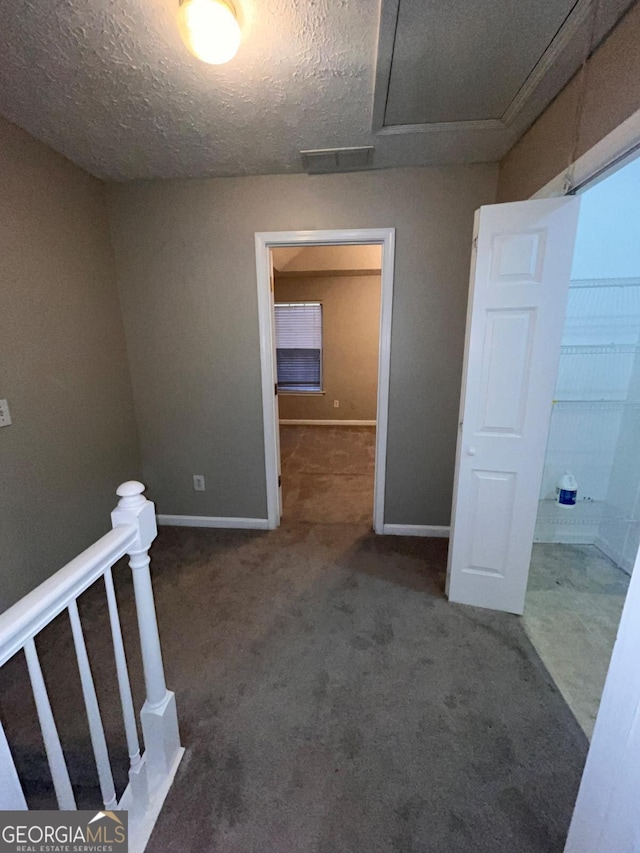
[2,524,587,853]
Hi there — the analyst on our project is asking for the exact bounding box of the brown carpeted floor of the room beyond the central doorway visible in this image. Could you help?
[280,425,376,525]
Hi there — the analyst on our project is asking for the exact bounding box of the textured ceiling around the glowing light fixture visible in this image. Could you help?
[0,0,629,180]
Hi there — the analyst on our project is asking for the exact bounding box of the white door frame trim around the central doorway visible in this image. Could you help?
[256,228,396,533]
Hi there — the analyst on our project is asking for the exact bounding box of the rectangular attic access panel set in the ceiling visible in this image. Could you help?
[383,0,578,127]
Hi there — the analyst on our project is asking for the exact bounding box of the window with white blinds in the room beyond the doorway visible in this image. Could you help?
[275,302,322,393]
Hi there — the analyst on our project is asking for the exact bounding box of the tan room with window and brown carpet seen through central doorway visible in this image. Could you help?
[272,245,382,526]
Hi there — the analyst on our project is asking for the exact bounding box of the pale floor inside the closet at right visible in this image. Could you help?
[523,543,629,738]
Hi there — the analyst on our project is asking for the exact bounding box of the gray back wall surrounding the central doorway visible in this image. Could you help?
[107,165,497,524]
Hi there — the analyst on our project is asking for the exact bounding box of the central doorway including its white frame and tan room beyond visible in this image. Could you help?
[256,229,395,533]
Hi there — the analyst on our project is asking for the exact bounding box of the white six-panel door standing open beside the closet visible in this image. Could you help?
[447,198,579,613]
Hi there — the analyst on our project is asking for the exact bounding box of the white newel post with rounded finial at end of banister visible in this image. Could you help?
[111,480,181,794]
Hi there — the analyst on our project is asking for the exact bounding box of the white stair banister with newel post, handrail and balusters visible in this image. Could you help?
[0,480,184,853]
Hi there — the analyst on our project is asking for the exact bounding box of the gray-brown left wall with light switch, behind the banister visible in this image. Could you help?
[0,119,141,609]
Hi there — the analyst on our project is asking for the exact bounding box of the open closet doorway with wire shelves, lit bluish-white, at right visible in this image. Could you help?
[524,150,640,737]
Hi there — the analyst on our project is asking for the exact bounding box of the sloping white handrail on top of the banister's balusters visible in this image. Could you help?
[0,524,138,666]
